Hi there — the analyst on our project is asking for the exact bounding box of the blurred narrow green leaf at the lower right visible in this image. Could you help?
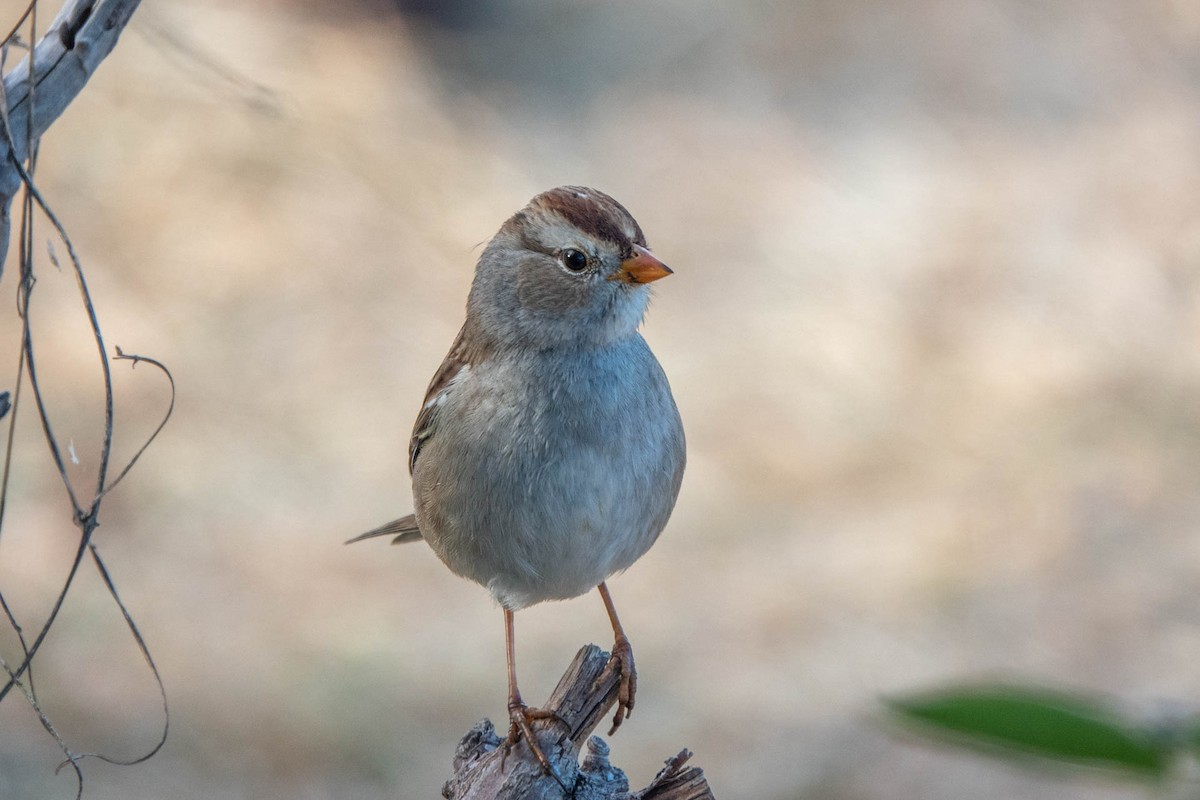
[886,686,1172,776]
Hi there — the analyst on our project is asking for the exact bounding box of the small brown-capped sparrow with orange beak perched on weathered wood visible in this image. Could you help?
[348,186,686,774]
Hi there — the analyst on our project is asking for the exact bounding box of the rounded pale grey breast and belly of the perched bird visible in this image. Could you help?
[413,343,684,609]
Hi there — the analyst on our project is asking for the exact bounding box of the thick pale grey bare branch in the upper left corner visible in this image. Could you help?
[0,0,140,273]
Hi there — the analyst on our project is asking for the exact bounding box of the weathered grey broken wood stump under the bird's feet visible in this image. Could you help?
[442,644,715,800]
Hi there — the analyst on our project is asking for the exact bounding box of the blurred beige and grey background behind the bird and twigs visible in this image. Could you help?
[0,0,1200,800]
